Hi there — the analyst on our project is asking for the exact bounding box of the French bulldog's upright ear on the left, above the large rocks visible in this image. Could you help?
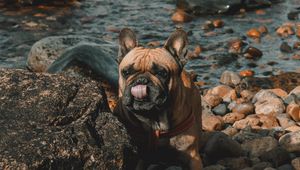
[118,28,138,63]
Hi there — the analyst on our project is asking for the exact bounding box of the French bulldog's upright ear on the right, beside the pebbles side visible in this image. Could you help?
[164,28,188,67]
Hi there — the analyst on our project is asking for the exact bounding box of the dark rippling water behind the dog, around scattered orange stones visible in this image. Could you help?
[0,0,300,83]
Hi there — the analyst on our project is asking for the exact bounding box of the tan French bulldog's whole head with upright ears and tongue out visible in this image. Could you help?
[119,28,187,117]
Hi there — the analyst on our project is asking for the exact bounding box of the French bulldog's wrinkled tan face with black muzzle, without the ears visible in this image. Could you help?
[119,47,180,114]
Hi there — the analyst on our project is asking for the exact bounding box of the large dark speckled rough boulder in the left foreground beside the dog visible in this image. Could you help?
[0,69,135,169]
